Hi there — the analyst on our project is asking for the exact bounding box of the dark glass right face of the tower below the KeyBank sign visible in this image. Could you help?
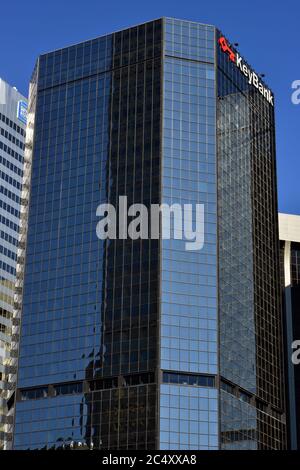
[216,31,286,449]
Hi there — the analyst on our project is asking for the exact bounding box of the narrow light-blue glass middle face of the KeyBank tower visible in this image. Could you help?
[160,19,218,449]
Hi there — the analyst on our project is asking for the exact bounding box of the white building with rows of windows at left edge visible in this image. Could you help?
[0,79,27,449]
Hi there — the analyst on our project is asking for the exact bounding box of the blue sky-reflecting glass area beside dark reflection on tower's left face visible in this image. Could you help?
[19,70,111,387]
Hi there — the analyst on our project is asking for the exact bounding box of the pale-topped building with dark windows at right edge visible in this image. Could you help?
[279,214,300,450]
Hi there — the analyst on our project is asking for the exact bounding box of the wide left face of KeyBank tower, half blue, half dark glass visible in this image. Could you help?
[14,21,161,449]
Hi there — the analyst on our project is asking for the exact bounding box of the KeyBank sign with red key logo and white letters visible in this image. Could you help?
[219,36,274,106]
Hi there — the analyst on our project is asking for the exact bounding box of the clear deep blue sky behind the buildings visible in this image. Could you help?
[0,0,300,214]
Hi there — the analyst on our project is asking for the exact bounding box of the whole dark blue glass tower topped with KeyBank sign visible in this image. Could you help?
[14,18,286,449]
